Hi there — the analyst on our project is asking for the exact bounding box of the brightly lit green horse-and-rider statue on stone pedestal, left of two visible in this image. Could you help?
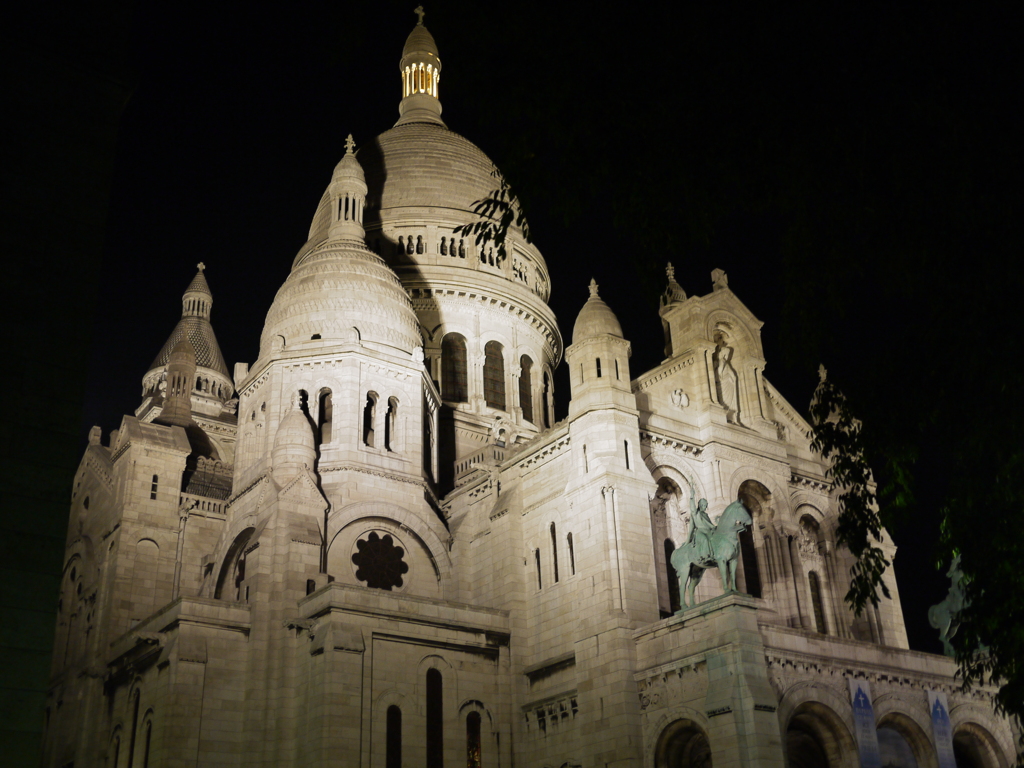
[671,499,753,610]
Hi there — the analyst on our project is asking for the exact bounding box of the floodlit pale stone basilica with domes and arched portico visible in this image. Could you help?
[44,12,1018,768]
